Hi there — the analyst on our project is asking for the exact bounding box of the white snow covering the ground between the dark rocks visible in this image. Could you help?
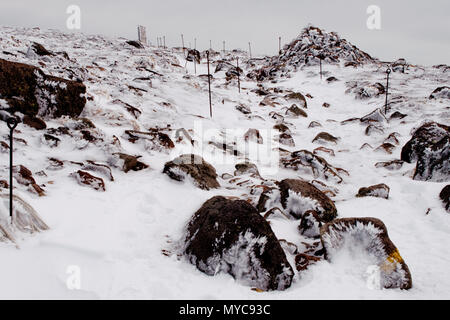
[0,27,450,299]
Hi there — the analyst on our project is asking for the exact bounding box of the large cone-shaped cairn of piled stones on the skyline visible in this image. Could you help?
[249,26,377,80]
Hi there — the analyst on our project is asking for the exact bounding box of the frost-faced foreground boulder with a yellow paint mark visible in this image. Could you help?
[320,218,412,289]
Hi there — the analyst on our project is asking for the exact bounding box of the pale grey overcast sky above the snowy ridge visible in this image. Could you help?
[0,0,450,65]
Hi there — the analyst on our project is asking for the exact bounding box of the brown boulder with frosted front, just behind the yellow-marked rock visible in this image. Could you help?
[279,179,337,222]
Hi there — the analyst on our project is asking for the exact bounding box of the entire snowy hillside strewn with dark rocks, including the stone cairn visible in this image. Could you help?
[0,27,450,299]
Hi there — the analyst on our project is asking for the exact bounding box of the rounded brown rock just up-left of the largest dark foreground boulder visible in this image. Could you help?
[163,154,220,190]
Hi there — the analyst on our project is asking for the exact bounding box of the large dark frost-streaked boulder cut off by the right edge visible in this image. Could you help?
[401,122,450,182]
